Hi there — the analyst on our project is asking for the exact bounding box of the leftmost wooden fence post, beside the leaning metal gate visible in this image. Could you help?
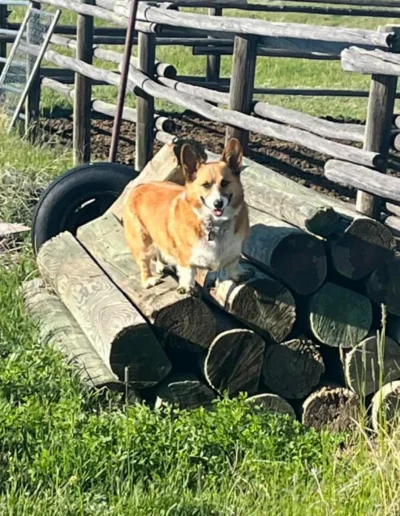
[25,2,41,142]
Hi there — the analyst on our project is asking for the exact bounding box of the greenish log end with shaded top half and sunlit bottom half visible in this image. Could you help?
[307,283,372,348]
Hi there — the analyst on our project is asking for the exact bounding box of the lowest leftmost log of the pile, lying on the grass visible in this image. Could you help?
[23,279,123,390]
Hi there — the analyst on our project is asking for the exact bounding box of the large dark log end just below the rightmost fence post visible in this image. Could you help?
[330,218,396,280]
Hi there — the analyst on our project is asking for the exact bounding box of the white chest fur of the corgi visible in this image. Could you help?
[191,221,242,271]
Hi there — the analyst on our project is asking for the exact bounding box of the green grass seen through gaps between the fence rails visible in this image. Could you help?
[10,4,400,120]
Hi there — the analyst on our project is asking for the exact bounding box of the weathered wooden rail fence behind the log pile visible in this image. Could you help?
[2,0,400,225]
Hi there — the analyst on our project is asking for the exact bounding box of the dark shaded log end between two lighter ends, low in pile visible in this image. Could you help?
[262,338,325,399]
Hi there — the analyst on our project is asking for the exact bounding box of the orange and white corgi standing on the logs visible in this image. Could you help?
[123,138,249,294]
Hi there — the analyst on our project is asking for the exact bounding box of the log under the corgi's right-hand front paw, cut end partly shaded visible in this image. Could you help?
[196,263,296,342]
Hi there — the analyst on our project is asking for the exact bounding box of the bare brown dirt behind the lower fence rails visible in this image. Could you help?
[39,112,400,201]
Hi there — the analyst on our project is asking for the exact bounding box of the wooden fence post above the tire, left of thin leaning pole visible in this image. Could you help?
[73,0,94,165]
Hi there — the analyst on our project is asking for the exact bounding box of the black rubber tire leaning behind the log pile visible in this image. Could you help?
[31,163,138,253]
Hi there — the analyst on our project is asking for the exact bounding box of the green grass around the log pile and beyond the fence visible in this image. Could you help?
[0,5,400,516]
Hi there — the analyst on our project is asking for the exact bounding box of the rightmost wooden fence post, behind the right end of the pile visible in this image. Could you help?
[356,25,400,220]
